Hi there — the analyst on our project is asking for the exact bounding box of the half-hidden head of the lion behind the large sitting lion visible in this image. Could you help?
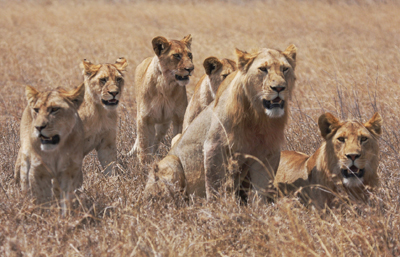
[203,57,236,98]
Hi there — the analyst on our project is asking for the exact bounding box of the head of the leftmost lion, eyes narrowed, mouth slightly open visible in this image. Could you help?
[25,84,85,151]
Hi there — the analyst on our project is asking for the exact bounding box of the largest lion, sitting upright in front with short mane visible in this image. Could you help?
[145,45,297,199]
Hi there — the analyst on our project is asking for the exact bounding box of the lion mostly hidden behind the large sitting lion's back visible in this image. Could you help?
[183,57,236,131]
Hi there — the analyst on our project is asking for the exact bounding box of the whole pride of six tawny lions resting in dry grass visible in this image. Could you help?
[15,35,382,208]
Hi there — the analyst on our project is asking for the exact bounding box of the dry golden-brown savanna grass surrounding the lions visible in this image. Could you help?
[0,0,400,256]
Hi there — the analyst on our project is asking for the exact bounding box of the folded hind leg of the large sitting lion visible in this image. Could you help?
[144,155,186,198]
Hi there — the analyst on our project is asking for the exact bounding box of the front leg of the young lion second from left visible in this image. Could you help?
[96,130,117,176]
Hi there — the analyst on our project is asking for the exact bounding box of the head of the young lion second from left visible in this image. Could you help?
[81,57,128,110]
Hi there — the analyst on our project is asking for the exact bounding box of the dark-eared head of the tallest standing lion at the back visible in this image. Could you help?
[152,35,194,86]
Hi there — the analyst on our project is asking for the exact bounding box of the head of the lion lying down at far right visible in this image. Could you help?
[318,113,382,189]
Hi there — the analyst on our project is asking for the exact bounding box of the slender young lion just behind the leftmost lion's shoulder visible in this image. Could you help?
[79,57,128,175]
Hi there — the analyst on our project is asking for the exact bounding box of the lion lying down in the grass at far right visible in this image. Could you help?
[274,113,382,209]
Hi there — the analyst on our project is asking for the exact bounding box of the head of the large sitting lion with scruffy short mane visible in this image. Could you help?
[237,45,296,118]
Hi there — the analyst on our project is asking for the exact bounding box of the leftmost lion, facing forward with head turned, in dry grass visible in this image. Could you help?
[14,85,85,206]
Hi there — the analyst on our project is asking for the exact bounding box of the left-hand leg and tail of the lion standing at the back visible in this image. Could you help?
[132,117,156,164]
